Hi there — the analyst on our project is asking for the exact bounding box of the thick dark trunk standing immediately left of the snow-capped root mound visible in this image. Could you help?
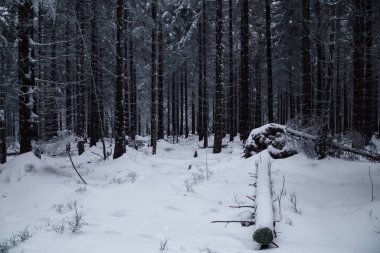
[239,0,250,142]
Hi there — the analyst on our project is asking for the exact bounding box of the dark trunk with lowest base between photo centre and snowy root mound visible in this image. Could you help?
[213,0,223,154]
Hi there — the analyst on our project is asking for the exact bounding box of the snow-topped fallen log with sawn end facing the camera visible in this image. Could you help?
[253,163,277,249]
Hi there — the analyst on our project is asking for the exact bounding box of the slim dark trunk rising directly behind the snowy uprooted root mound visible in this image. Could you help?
[265,0,274,123]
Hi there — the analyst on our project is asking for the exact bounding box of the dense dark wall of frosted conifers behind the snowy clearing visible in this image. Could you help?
[0,0,380,162]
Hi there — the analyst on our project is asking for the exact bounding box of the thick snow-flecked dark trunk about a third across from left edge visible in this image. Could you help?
[113,0,126,159]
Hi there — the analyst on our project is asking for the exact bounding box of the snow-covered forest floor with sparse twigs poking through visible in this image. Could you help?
[0,136,380,253]
